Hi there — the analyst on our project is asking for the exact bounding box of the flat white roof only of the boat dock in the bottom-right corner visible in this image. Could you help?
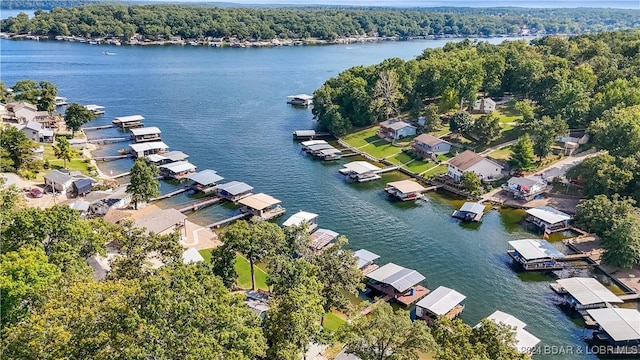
[587,308,640,341]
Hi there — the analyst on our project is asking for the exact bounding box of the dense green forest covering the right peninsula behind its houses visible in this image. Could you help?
[313,30,640,266]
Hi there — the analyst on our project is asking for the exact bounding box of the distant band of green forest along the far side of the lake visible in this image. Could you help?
[1,5,640,40]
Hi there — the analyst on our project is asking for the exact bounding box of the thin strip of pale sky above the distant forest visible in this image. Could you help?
[154,0,640,9]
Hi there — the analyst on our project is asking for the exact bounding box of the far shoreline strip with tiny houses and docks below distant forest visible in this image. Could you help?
[0,32,544,47]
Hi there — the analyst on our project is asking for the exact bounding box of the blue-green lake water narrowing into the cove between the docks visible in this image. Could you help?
[0,40,590,359]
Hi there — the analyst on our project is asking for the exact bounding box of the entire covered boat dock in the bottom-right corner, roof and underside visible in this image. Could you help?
[587,308,640,355]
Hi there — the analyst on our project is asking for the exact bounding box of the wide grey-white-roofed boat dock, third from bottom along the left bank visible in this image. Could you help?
[366,263,429,306]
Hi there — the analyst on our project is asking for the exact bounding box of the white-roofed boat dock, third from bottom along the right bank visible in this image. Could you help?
[507,239,565,271]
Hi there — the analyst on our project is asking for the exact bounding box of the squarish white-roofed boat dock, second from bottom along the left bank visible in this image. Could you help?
[416,286,467,324]
